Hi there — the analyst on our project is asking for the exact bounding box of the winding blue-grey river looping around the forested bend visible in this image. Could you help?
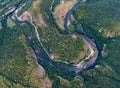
[3,1,99,72]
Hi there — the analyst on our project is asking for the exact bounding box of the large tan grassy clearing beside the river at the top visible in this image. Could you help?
[53,0,76,29]
